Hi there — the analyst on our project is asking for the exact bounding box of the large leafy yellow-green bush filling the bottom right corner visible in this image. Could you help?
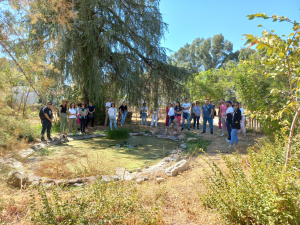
[201,139,300,225]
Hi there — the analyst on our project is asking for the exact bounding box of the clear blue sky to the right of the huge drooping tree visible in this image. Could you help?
[160,0,300,54]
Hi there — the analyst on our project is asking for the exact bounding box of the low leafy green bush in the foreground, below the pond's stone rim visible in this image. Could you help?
[30,180,159,224]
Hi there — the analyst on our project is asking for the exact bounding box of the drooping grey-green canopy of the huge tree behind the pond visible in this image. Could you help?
[30,0,189,109]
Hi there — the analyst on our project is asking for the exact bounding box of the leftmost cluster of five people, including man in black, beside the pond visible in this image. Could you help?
[40,100,96,141]
